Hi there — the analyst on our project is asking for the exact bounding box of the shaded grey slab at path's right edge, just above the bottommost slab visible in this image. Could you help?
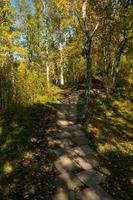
[77,169,105,186]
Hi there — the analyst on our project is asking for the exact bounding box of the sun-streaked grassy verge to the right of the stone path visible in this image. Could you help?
[79,90,133,200]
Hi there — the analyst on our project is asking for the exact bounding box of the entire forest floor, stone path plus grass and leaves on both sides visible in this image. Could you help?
[0,91,133,200]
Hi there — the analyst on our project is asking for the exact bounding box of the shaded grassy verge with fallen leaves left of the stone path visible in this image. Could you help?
[0,88,60,200]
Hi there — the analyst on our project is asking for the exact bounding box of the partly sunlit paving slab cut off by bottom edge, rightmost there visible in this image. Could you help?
[77,186,113,200]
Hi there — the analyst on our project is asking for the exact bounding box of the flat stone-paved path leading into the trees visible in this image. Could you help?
[51,92,112,200]
